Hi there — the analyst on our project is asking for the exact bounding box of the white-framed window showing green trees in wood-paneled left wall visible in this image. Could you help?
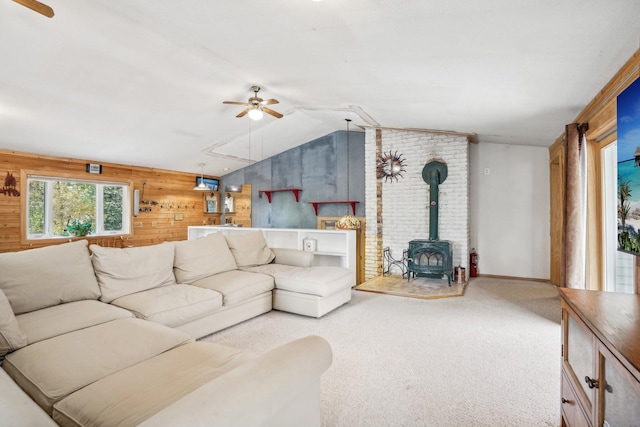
[25,175,131,239]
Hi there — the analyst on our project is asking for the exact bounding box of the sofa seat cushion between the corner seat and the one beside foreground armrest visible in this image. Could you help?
[3,319,193,415]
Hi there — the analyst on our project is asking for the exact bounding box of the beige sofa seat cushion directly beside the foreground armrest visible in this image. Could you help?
[53,342,255,426]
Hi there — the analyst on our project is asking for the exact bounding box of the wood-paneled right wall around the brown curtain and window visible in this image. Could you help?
[549,50,640,290]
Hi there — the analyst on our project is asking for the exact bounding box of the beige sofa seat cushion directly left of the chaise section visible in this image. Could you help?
[193,270,273,305]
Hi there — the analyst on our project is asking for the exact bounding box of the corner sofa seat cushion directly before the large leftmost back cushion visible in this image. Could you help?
[17,300,134,344]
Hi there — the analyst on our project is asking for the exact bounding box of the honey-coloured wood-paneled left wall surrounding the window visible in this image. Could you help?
[0,150,220,252]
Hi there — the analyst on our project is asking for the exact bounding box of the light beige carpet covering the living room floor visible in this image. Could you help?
[204,278,560,427]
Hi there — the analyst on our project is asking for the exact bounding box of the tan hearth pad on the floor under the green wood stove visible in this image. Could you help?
[356,275,467,299]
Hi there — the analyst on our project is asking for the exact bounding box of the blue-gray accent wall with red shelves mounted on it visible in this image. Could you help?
[221,131,365,228]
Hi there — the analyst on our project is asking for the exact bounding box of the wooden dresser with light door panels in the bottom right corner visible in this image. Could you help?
[560,289,640,427]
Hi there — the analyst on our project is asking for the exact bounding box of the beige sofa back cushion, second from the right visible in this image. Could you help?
[173,233,238,283]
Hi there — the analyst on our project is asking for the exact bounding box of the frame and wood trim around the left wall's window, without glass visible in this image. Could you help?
[20,169,134,245]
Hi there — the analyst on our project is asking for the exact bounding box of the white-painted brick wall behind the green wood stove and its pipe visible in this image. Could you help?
[365,129,470,279]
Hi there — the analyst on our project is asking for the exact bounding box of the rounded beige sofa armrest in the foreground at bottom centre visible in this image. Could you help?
[140,336,333,427]
